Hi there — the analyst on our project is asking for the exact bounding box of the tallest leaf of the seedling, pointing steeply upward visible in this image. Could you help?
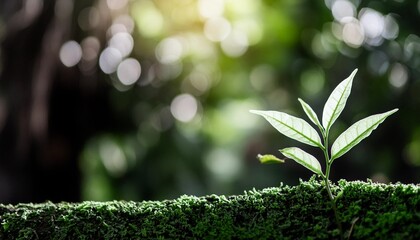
[322,68,357,133]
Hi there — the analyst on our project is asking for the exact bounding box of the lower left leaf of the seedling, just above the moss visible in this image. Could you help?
[280,147,322,175]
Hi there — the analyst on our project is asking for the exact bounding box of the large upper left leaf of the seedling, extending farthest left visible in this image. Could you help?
[250,110,323,148]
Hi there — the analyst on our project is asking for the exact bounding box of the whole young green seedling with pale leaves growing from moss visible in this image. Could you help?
[250,69,398,237]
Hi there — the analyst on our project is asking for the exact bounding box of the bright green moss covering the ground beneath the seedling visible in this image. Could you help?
[0,179,420,239]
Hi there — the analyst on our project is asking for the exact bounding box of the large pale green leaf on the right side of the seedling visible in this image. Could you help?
[331,109,398,161]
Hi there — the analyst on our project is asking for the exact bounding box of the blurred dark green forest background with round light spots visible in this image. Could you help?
[0,0,420,203]
